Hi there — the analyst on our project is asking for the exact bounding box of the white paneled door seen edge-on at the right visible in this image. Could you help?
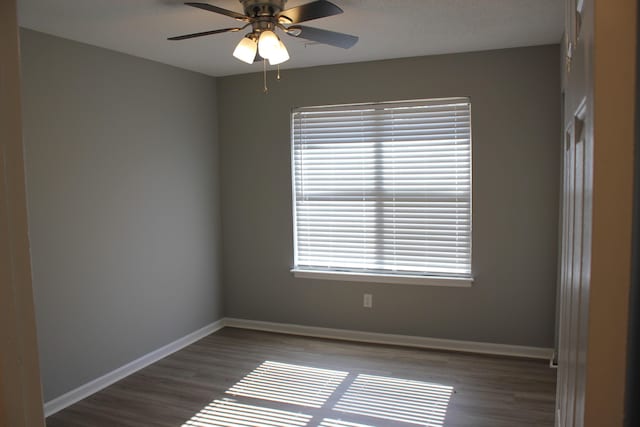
[556,0,593,427]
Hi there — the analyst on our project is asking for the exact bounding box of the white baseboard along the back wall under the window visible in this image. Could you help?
[224,317,553,360]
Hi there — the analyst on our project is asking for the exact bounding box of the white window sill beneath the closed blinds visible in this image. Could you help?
[291,268,473,288]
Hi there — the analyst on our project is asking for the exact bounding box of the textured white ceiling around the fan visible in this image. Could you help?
[18,0,563,76]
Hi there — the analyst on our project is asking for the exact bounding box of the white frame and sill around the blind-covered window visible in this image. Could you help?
[290,96,474,287]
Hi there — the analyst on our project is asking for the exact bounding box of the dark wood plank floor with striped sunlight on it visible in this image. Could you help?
[47,328,556,427]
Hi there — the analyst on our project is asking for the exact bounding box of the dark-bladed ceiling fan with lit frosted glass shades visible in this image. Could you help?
[168,0,358,65]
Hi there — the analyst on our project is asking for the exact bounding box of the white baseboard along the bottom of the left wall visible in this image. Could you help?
[44,319,224,417]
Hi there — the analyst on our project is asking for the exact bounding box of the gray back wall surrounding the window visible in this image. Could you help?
[218,46,560,347]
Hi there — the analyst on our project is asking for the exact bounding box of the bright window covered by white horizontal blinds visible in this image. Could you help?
[292,98,471,286]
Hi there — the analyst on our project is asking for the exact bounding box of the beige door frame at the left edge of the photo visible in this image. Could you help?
[0,0,44,427]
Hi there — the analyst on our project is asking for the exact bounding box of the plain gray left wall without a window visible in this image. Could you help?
[21,30,223,401]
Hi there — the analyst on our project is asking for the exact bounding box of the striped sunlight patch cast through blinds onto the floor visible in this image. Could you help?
[182,361,454,427]
